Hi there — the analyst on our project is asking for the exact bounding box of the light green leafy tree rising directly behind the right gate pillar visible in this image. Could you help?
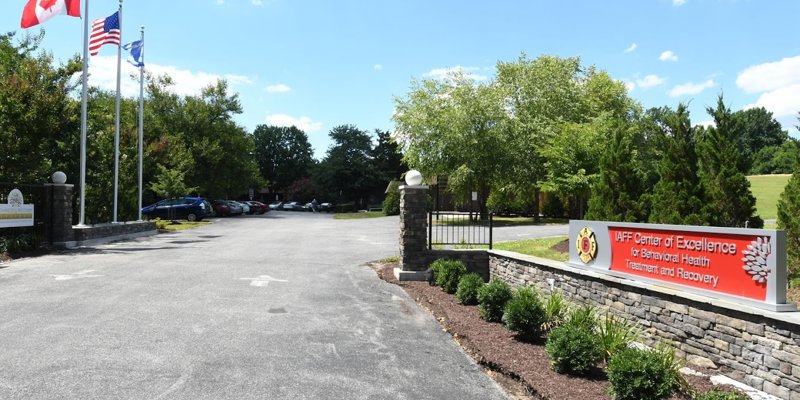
[393,72,511,215]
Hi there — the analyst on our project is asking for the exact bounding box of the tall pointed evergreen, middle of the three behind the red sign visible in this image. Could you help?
[650,104,708,225]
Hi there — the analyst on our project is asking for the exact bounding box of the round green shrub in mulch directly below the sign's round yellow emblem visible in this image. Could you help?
[544,324,602,375]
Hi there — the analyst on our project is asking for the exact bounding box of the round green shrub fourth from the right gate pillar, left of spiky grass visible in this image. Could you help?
[503,287,545,339]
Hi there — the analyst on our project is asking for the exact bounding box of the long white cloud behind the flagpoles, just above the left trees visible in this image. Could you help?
[89,56,253,97]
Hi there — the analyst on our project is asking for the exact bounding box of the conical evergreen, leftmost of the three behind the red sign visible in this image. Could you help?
[586,122,647,222]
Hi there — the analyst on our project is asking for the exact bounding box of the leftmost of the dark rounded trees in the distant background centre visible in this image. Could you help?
[253,125,314,190]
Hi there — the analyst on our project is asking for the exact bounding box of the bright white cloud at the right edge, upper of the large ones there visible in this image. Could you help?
[736,56,800,93]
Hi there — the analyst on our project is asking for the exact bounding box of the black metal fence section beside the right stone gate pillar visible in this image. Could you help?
[428,211,494,250]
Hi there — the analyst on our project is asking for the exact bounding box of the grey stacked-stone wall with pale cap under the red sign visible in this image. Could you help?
[488,251,800,400]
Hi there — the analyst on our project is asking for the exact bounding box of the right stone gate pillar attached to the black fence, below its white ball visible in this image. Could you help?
[394,185,428,281]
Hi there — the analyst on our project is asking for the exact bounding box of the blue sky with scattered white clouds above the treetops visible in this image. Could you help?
[0,0,800,158]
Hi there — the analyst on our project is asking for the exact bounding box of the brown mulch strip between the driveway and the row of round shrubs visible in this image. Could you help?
[370,262,728,400]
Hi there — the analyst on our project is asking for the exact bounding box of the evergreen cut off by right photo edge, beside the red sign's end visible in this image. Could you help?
[778,116,800,279]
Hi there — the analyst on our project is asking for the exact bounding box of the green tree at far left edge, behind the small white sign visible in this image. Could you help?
[0,31,81,183]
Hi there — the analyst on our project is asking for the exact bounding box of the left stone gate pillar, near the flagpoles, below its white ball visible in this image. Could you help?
[45,184,75,248]
